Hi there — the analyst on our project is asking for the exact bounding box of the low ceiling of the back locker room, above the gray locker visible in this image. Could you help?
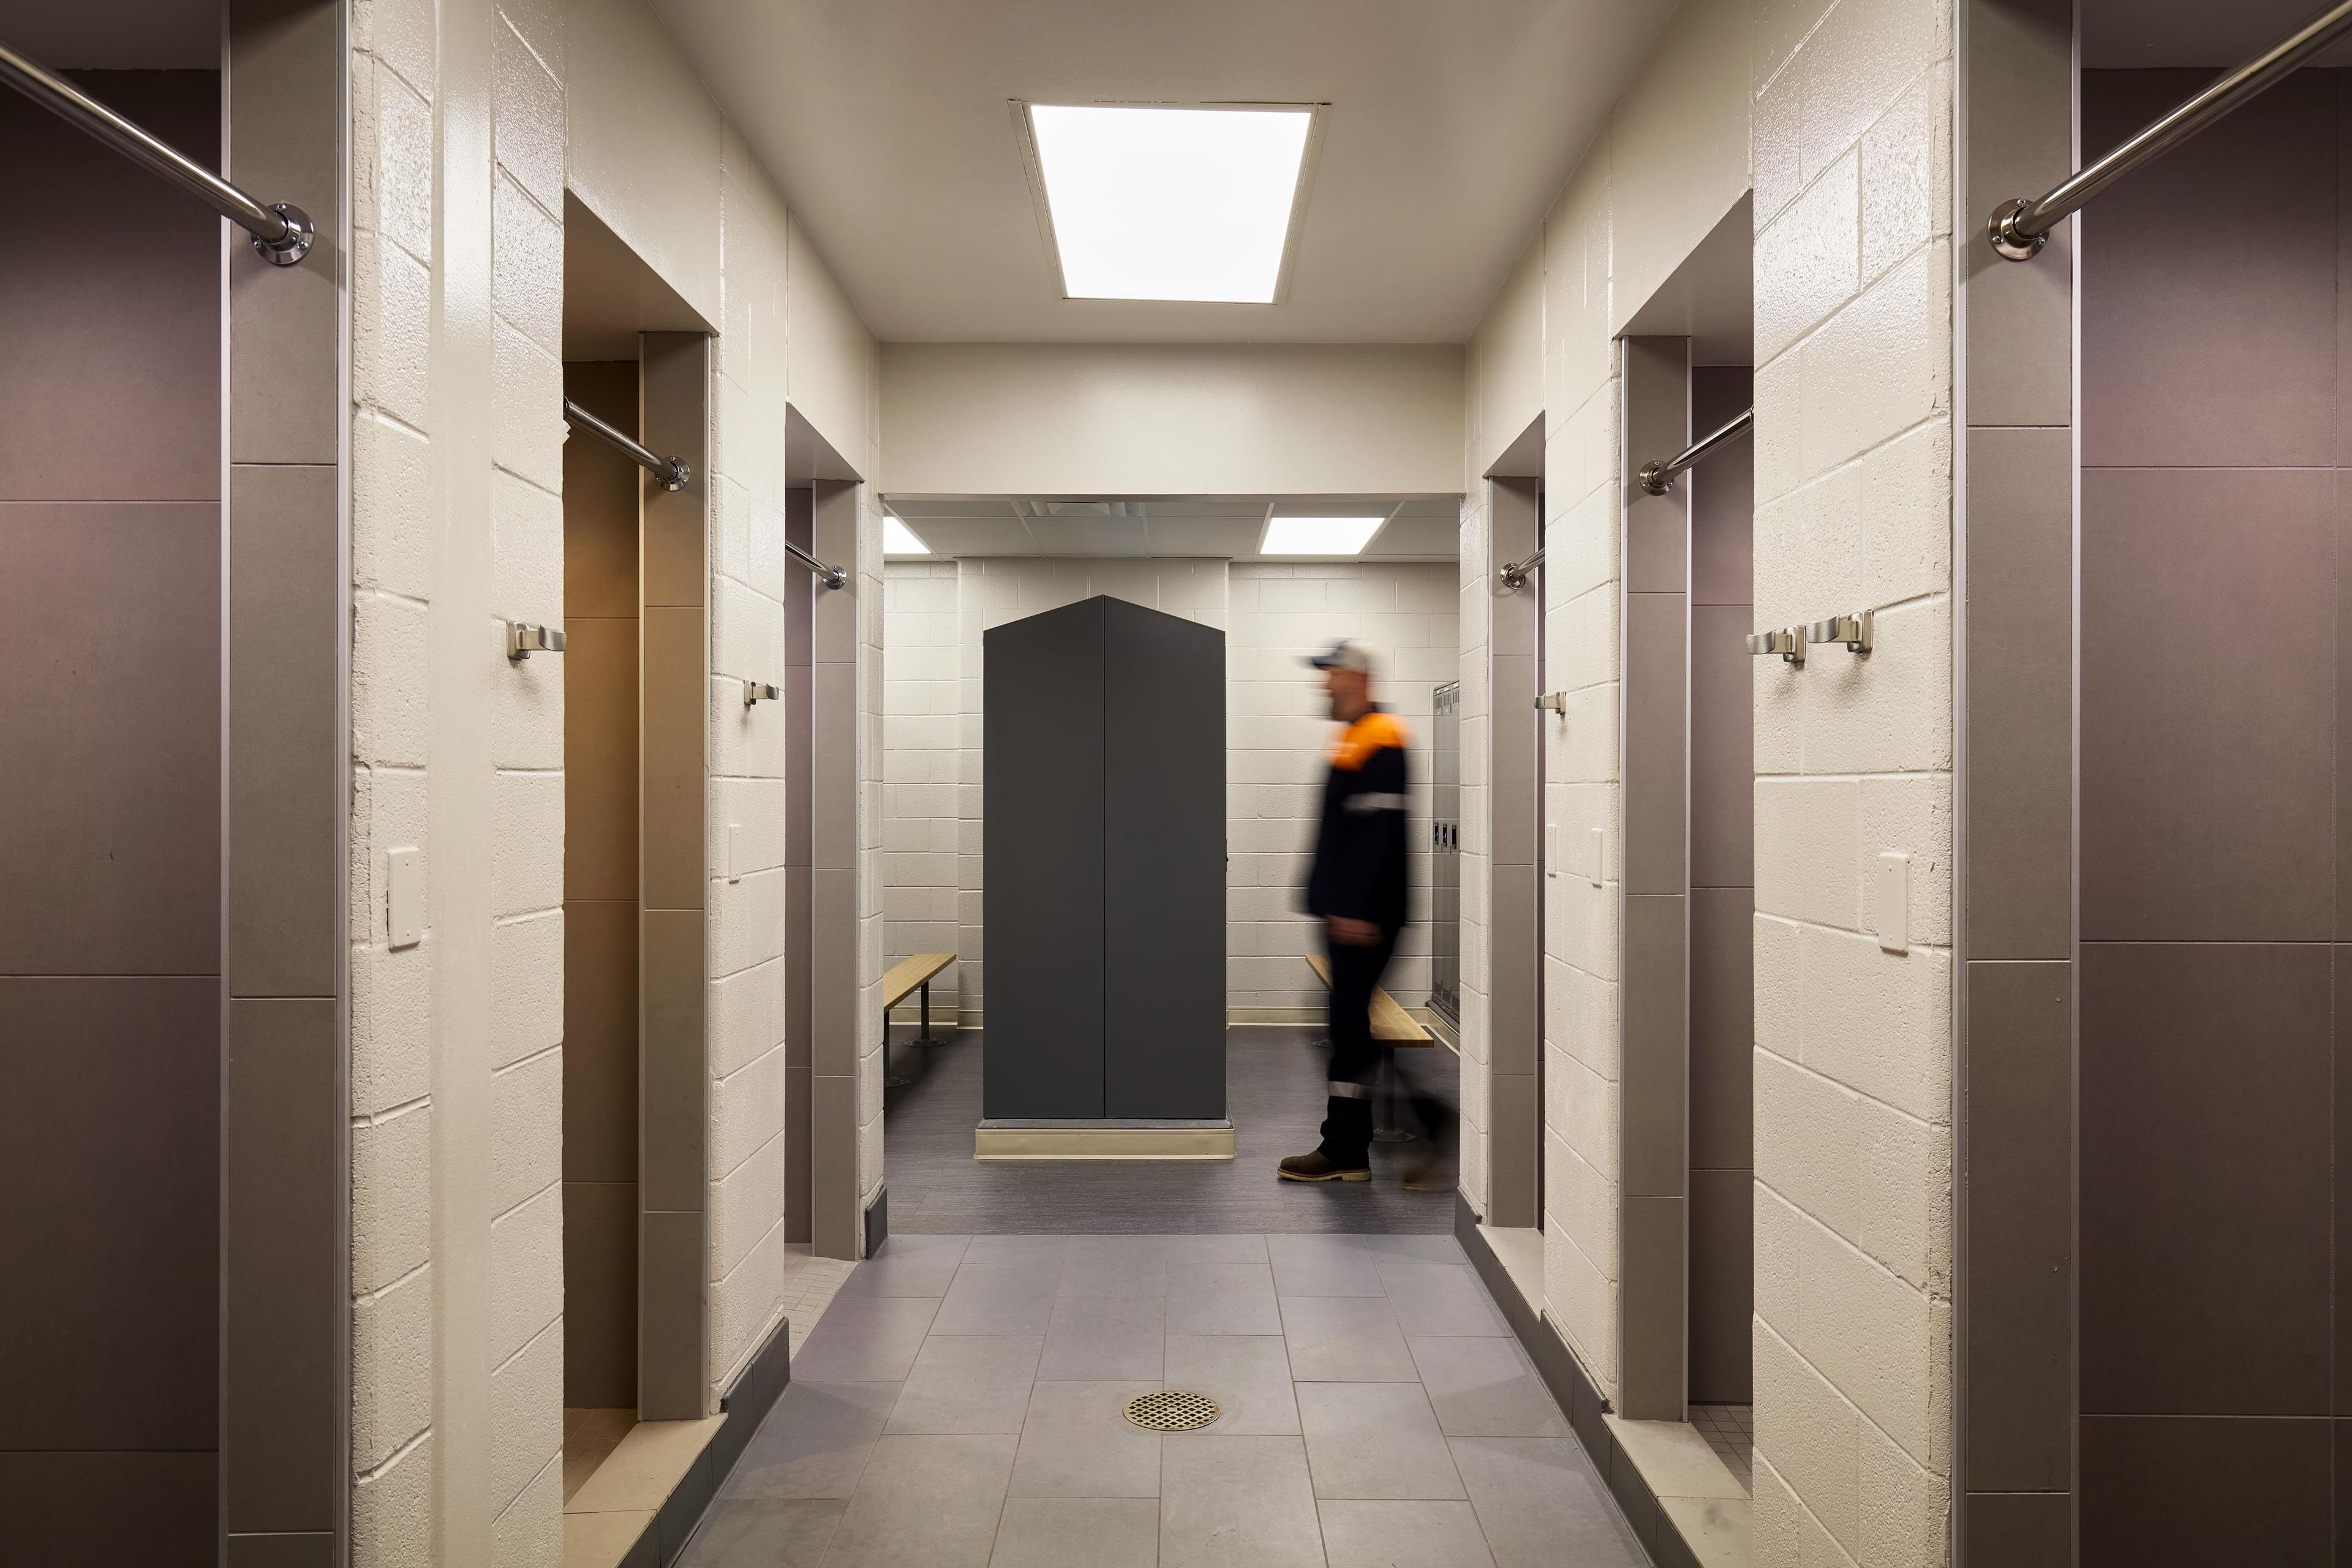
[884,496,1461,562]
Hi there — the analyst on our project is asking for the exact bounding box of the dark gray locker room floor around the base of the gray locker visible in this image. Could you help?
[882,1025,1461,1237]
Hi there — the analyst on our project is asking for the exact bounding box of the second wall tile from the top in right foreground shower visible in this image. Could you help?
[2081,468,2335,940]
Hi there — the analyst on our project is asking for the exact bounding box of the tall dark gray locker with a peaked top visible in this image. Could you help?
[981,597,1226,1121]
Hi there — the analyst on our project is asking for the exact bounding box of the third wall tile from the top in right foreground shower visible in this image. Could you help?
[2079,943,2333,1420]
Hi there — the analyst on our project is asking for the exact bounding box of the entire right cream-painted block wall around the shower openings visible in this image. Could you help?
[1463,0,1952,1563]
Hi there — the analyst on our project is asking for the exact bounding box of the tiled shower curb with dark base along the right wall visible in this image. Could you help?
[1453,1204,1750,1568]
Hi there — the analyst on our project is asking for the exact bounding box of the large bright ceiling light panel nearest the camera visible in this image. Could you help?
[1028,104,1315,306]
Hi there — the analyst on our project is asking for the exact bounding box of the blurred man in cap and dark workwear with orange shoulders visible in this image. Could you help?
[1282,637,1411,1183]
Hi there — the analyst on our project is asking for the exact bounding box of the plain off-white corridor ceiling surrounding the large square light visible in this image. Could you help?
[652,0,1675,343]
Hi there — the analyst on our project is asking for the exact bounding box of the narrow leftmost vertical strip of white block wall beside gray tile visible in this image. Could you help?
[348,0,437,1563]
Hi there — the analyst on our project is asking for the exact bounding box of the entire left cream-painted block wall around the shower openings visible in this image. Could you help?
[348,0,882,1563]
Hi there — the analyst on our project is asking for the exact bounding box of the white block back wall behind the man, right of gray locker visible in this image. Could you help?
[1226,562,1461,1018]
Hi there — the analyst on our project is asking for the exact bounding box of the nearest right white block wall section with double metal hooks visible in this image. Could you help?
[1752,0,1952,1568]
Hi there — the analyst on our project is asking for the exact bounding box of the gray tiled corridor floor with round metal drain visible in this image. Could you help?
[684,1234,1644,1568]
